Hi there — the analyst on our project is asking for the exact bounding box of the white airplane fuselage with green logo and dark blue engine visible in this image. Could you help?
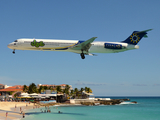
[8,39,139,54]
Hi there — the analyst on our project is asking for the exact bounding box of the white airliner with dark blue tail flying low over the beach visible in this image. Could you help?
[8,29,152,59]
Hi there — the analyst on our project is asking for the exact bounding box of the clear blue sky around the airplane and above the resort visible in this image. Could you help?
[0,0,160,96]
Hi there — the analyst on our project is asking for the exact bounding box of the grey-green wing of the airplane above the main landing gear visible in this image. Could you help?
[70,37,97,52]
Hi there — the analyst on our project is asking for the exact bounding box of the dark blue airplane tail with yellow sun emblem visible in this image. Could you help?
[122,29,152,45]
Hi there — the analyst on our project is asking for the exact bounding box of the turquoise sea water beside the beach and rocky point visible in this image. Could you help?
[24,97,160,120]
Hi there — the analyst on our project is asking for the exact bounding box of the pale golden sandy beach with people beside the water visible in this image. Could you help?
[0,102,34,120]
